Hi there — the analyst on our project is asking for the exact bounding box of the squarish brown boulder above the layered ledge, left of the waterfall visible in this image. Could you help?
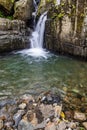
[14,0,33,21]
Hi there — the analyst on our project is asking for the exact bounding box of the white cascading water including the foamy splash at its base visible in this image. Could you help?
[16,1,48,58]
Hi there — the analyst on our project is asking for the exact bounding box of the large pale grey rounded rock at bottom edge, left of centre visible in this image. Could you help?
[18,119,34,130]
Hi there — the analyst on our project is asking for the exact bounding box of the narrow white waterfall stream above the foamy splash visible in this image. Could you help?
[30,12,47,48]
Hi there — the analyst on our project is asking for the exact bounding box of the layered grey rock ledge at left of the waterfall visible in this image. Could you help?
[0,18,29,53]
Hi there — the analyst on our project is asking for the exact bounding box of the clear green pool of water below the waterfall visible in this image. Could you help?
[0,54,87,97]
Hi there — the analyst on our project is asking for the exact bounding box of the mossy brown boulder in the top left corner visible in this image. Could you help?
[0,0,15,13]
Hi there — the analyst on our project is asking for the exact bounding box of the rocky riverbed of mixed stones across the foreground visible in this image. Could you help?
[0,91,87,130]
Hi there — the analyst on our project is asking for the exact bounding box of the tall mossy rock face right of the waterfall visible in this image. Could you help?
[42,0,87,57]
